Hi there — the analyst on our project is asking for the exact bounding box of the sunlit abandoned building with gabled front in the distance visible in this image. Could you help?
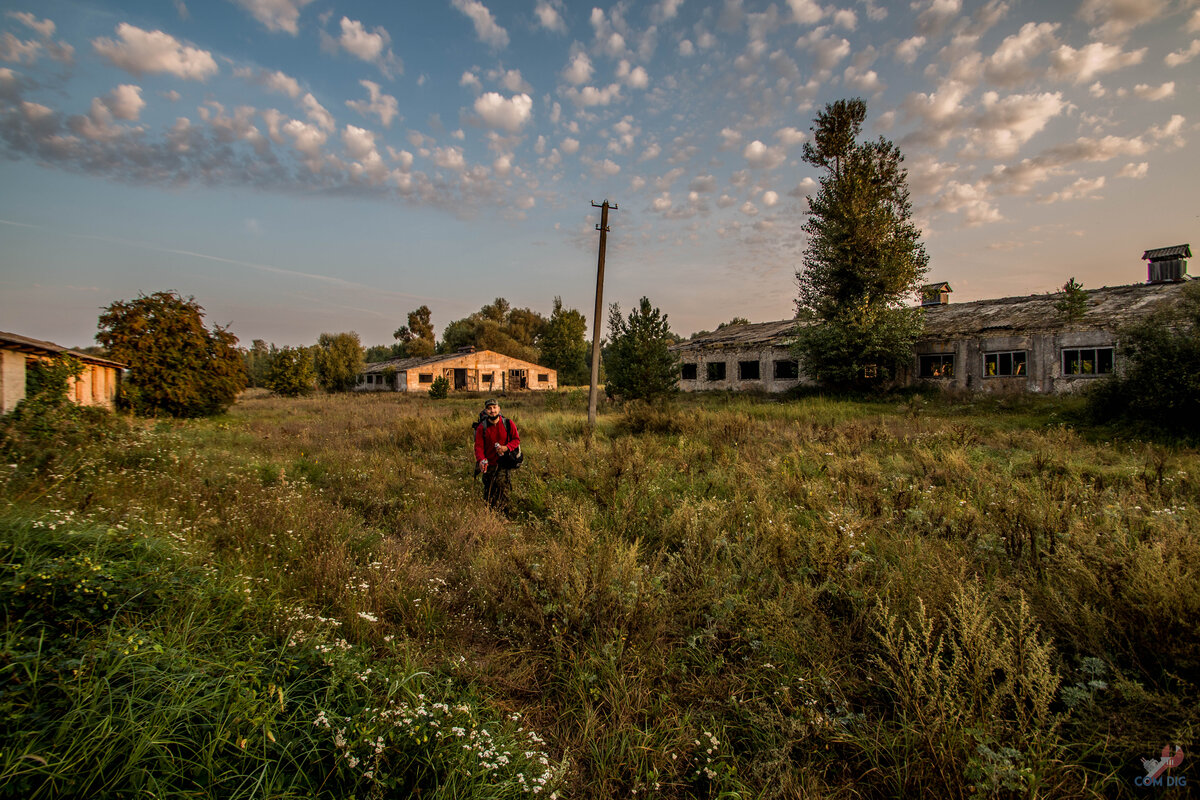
[354,348,558,392]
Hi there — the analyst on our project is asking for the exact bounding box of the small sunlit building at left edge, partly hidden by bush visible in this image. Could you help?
[0,331,126,414]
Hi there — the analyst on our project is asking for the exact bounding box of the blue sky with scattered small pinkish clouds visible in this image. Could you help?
[0,0,1200,347]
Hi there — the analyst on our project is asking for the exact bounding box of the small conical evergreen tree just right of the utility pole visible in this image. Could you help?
[601,297,678,401]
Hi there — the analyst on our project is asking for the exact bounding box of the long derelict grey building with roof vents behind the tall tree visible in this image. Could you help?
[672,245,1192,392]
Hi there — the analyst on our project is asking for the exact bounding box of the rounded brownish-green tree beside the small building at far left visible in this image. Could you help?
[96,291,246,416]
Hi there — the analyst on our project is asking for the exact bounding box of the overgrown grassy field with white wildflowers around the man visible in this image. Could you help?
[0,391,1200,799]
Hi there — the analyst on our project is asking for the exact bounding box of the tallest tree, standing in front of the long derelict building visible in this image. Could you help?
[796,100,929,386]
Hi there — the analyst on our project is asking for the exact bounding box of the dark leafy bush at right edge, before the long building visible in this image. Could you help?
[1087,282,1200,438]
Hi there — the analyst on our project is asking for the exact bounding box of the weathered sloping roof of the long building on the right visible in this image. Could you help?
[671,281,1188,353]
